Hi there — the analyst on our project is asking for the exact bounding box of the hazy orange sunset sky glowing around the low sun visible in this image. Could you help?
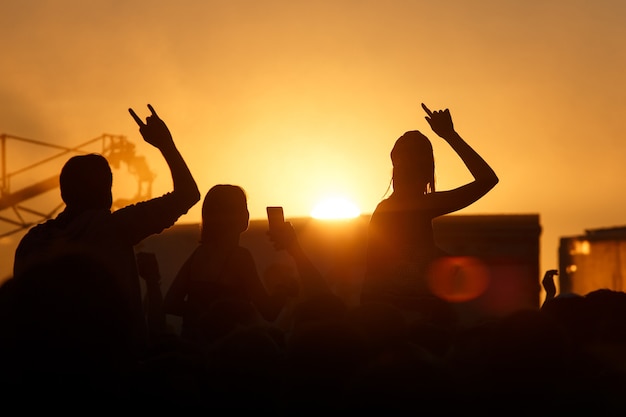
[0,0,626,278]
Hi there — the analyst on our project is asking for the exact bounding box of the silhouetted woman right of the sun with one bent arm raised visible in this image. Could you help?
[361,104,498,314]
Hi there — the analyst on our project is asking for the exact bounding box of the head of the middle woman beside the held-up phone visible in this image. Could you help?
[200,184,250,242]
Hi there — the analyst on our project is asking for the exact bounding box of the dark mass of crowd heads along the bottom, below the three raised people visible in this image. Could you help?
[0,257,626,416]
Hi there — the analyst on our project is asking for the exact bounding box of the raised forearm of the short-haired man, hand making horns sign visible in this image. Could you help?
[128,104,200,208]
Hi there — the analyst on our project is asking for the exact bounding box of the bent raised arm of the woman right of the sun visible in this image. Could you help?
[422,103,499,212]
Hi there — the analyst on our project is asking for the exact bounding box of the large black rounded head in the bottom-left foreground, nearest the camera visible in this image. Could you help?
[0,253,137,408]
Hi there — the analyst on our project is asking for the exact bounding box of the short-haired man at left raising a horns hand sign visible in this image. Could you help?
[13,105,200,352]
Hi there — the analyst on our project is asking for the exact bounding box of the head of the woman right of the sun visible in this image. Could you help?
[391,130,435,194]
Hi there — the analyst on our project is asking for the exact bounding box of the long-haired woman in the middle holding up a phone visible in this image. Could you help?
[164,184,326,340]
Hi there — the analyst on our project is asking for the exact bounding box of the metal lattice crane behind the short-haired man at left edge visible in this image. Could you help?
[0,134,156,237]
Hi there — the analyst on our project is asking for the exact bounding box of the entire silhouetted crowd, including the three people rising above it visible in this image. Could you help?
[0,105,626,416]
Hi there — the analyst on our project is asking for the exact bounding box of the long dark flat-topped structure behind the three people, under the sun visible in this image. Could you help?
[138,214,541,326]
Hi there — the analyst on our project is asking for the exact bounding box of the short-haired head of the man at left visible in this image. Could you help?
[59,153,113,211]
